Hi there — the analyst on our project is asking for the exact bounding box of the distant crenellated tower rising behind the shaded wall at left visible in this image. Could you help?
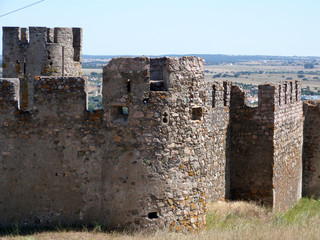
[2,27,82,110]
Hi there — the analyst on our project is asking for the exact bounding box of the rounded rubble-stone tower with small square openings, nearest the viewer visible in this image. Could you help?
[101,57,212,231]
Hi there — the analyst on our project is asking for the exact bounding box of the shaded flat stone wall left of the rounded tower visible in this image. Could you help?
[0,77,103,227]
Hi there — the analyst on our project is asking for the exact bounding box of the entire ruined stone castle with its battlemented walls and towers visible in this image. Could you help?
[0,27,319,231]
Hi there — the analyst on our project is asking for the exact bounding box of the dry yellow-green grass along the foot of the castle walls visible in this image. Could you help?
[1,199,320,240]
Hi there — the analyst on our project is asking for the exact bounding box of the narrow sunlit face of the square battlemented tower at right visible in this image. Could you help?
[273,81,304,210]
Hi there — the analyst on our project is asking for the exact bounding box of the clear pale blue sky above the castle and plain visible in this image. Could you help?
[0,0,320,56]
